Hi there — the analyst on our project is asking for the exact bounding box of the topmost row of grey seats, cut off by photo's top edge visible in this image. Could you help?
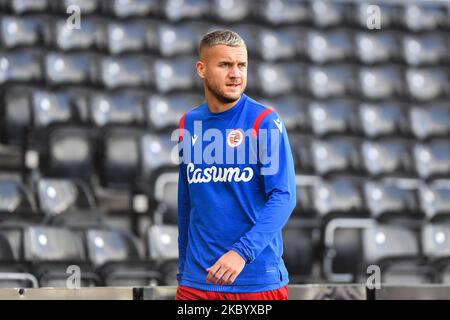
[0,0,450,31]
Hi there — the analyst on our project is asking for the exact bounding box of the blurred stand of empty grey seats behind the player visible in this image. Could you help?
[0,0,450,287]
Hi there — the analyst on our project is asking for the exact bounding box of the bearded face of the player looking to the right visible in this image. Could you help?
[197,45,247,103]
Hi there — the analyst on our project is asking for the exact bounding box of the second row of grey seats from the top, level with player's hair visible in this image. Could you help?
[0,15,450,66]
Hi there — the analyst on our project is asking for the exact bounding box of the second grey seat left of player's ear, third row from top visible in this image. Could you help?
[100,56,154,89]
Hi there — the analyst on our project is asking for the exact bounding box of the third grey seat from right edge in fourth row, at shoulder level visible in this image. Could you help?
[308,100,359,136]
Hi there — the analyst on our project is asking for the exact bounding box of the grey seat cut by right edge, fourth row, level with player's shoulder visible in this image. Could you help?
[408,102,450,139]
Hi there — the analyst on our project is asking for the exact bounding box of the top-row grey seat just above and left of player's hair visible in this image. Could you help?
[162,0,210,22]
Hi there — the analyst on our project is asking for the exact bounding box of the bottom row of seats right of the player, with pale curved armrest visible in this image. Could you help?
[283,219,450,285]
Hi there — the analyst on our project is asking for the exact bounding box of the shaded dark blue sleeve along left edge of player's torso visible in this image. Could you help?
[177,154,191,281]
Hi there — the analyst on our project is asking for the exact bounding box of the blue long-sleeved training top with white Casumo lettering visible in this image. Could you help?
[177,94,296,292]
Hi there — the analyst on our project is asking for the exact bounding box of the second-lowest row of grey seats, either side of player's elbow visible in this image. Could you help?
[0,176,450,225]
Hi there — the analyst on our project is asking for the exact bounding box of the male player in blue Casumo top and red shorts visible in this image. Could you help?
[176,30,296,300]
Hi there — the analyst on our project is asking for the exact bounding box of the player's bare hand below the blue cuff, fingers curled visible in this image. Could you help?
[206,250,245,285]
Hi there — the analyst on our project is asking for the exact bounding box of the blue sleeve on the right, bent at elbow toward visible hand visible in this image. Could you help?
[232,113,296,263]
